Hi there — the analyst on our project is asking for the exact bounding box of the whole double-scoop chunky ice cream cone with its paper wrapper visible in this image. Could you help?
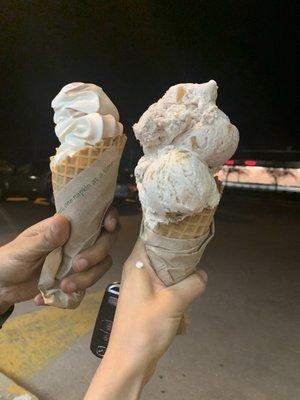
[133,81,239,285]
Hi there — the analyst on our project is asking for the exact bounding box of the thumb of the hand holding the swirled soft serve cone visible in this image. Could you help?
[26,214,70,255]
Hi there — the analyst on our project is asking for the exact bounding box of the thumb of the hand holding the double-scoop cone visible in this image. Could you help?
[167,271,207,312]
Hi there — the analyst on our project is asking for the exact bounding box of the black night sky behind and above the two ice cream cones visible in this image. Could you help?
[0,0,299,165]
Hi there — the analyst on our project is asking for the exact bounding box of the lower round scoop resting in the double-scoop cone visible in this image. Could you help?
[135,146,220,229]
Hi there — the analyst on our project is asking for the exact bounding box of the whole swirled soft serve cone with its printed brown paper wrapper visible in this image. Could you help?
[39,82,126,308]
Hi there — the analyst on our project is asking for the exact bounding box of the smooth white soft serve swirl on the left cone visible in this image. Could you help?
[51,82,123,165]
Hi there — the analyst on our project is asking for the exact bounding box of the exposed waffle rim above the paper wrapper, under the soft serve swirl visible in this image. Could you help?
[51,135,125,193]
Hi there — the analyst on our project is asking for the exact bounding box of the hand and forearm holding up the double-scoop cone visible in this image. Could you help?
[84,239,207,400]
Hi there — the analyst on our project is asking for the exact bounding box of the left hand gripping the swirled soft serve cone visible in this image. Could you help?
[0,208,118,314]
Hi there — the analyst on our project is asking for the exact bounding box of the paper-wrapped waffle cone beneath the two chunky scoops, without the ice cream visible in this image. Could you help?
[140,180,222,286]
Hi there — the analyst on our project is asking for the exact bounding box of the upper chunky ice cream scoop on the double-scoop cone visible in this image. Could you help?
[133,80,239,168]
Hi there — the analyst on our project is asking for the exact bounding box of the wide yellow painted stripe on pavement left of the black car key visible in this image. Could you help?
[0,291,103,380]
